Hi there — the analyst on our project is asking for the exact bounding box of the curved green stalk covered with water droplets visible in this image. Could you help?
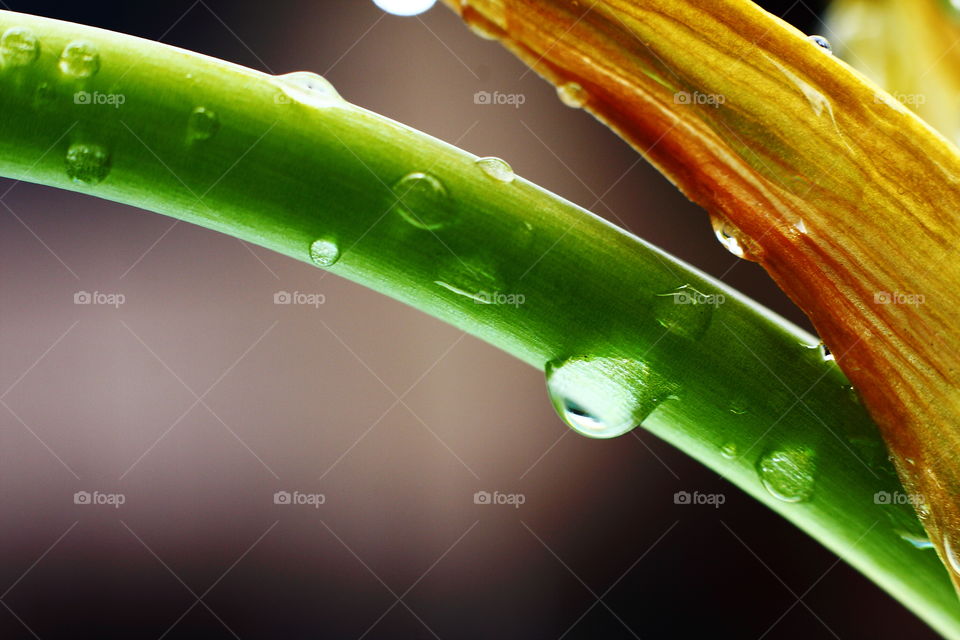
[0,7,960,638]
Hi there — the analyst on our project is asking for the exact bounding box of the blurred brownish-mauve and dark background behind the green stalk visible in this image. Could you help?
[0,0,934,640]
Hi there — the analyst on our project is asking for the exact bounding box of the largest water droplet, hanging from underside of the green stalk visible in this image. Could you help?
[546,356,671,438]
